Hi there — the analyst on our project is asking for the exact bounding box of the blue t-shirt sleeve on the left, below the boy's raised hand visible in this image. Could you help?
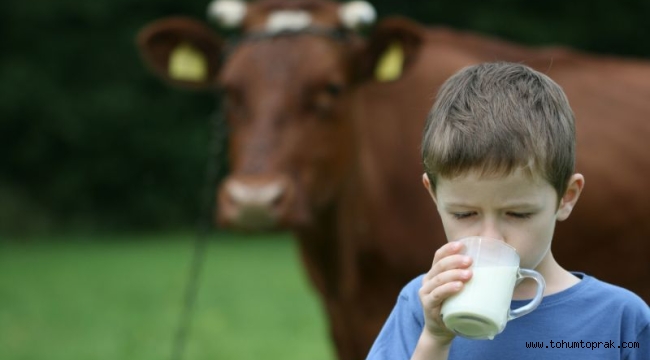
[366,277,424,360]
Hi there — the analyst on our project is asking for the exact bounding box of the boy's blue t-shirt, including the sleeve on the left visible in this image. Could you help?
[367,273,650,360]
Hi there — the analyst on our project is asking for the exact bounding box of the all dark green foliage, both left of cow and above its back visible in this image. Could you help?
[0,0,650,233]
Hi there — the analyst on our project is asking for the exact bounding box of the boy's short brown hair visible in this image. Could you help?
[422,62,575,201]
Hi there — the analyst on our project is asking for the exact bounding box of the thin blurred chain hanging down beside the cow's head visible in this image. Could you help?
[171,109,228,360]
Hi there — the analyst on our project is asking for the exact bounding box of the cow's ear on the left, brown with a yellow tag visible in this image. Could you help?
[136,17,223,90]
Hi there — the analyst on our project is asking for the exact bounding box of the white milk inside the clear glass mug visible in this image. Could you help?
[441,266,519,339]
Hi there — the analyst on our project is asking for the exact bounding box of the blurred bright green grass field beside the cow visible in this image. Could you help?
[0,234,334,360]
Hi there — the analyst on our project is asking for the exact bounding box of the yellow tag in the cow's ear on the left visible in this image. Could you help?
[168,43,208,82]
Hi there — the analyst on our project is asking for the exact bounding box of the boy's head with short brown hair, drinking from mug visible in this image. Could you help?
[422,63,584,270]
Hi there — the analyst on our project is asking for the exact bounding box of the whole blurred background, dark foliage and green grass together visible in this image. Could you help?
[0,0,650,360]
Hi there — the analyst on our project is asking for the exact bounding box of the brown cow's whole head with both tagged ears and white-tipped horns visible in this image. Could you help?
[138,0,420,229]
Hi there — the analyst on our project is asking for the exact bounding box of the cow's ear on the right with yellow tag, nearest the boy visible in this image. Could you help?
[357,17,425,82]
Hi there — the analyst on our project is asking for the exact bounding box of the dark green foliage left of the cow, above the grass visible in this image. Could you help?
[0,0,214,230]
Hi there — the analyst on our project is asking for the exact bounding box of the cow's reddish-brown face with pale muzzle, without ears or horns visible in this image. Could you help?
[218,34,354,228]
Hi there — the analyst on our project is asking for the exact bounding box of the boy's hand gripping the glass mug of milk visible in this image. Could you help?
[419,242,472,345]
